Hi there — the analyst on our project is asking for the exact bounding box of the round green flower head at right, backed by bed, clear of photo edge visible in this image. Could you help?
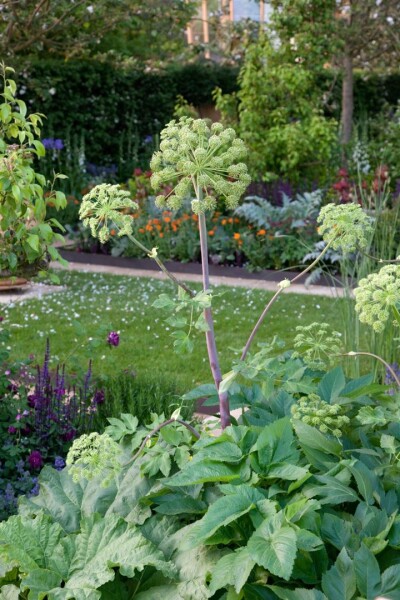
[317,203,373,253]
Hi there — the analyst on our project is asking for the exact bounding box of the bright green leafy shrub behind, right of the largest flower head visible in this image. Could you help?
[218,38,337,182]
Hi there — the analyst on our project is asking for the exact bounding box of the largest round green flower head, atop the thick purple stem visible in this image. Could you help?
[150,117,251,214]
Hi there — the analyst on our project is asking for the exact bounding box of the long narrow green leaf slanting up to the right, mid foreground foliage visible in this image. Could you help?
[183,485,272,547]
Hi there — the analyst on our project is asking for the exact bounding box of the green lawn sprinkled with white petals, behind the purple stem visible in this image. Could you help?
[2,272,354,391]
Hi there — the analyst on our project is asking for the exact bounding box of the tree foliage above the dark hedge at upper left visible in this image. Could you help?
[0,0,196,65]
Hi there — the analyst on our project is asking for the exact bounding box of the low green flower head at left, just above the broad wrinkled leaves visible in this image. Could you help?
[66,432,121,487]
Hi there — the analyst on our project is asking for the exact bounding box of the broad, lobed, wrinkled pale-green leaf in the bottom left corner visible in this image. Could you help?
[0,514,175,600]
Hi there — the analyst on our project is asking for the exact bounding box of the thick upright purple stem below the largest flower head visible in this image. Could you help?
[198,209,231,429]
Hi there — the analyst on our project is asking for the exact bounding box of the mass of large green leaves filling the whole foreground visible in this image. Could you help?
[0,356,400,600]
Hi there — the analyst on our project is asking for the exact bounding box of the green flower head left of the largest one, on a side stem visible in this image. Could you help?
[79,183,138,244]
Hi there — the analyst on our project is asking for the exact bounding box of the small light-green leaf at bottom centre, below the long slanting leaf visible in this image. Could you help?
[210,548,256,594]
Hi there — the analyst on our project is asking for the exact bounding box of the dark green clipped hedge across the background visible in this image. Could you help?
[15,60,400,178]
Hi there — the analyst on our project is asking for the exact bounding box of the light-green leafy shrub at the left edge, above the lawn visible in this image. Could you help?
[0,65,66,276]
